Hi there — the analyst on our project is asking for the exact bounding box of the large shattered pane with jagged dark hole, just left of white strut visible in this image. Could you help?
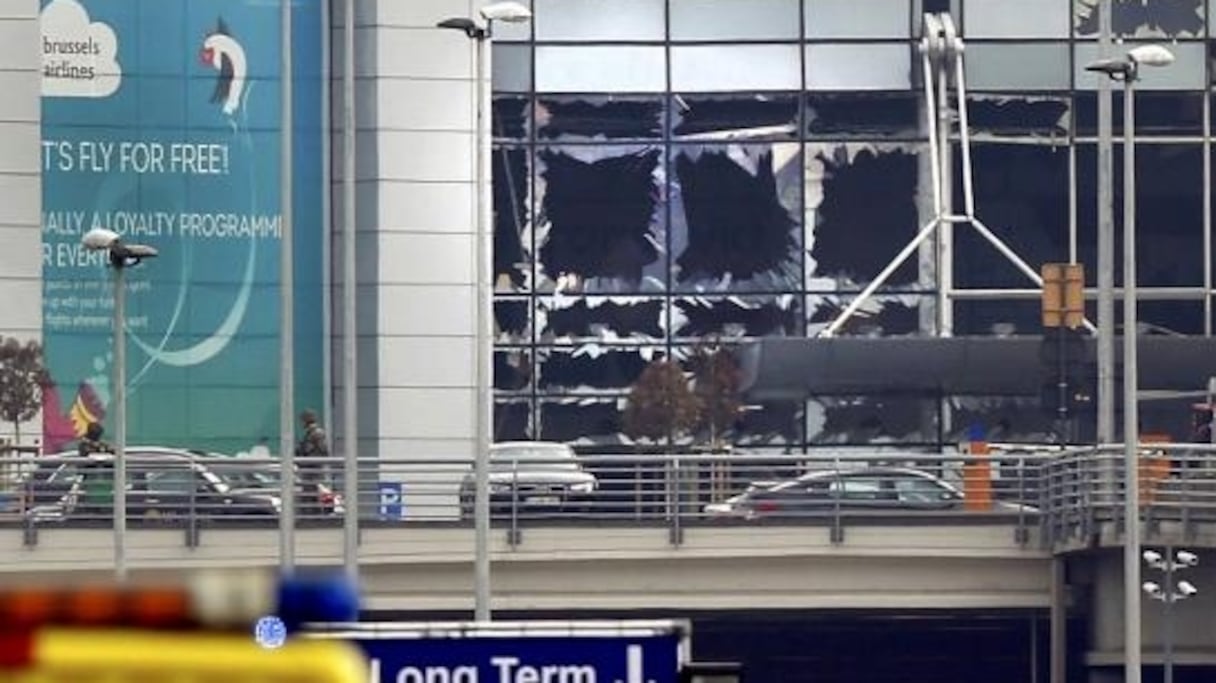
[806,142,921,292]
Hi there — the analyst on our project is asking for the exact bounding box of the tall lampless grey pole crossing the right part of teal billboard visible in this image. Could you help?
[278,0,295,572]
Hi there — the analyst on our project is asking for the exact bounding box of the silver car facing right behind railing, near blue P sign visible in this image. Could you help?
[460,441,599,519]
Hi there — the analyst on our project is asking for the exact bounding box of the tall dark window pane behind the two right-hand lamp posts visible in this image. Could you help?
[1076,142,1204,287]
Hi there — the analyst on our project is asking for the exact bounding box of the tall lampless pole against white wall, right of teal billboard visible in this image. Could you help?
[342,0,360,581]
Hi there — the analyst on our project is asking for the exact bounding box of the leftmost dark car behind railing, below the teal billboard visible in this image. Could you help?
[21,447,281,523]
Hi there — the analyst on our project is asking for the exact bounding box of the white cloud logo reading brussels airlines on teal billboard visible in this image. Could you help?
[41,0,123,97]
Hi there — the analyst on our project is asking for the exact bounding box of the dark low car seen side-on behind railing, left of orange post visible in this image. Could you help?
[704,467,1034,519]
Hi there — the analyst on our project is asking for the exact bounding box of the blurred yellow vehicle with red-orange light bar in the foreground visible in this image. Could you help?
[0,575,368,683]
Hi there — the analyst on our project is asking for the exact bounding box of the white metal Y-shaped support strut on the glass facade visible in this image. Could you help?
[818,12,1097,337]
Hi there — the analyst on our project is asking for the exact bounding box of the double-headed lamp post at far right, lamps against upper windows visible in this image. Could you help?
[1085,45,1173,683]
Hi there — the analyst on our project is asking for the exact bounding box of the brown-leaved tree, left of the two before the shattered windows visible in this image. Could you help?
[624,360,700,448]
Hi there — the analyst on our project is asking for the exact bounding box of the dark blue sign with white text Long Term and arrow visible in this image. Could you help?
[356,633,681,683]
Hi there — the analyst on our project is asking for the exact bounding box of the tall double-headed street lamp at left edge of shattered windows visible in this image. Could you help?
[437,2,531,621]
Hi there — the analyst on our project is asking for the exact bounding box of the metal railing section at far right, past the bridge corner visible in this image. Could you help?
[1043,444,1216,544]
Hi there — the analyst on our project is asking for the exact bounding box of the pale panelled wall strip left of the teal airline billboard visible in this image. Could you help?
[0,0,43,444]
